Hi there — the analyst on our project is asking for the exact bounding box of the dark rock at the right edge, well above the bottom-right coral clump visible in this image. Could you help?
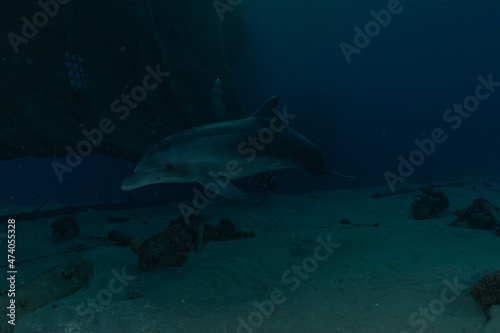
[450,198,500,230]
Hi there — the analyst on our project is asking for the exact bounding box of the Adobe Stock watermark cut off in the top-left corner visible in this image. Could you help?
[7,0,70,54]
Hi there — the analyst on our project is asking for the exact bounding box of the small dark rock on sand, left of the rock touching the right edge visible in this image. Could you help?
[411,188,450,220]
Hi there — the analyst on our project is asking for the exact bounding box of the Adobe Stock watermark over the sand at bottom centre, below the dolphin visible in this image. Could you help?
[236,235,341,333]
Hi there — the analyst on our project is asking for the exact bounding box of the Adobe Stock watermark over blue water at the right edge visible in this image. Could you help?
[384,74,500,192]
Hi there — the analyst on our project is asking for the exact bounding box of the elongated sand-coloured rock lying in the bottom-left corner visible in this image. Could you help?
[0,257,92,333]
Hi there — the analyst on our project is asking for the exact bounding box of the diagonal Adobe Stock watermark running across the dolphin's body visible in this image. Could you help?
[177,106,297,224]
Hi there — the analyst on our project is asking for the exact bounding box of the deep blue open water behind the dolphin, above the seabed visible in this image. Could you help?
[0,0,500,206]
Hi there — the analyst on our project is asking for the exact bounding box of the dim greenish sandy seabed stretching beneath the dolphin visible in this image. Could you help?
[1,181,500,333]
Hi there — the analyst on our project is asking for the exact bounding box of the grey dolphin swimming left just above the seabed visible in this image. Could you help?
[121,96,352,199]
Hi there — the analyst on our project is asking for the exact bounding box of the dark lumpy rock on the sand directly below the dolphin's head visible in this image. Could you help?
[137,226,193,272]
